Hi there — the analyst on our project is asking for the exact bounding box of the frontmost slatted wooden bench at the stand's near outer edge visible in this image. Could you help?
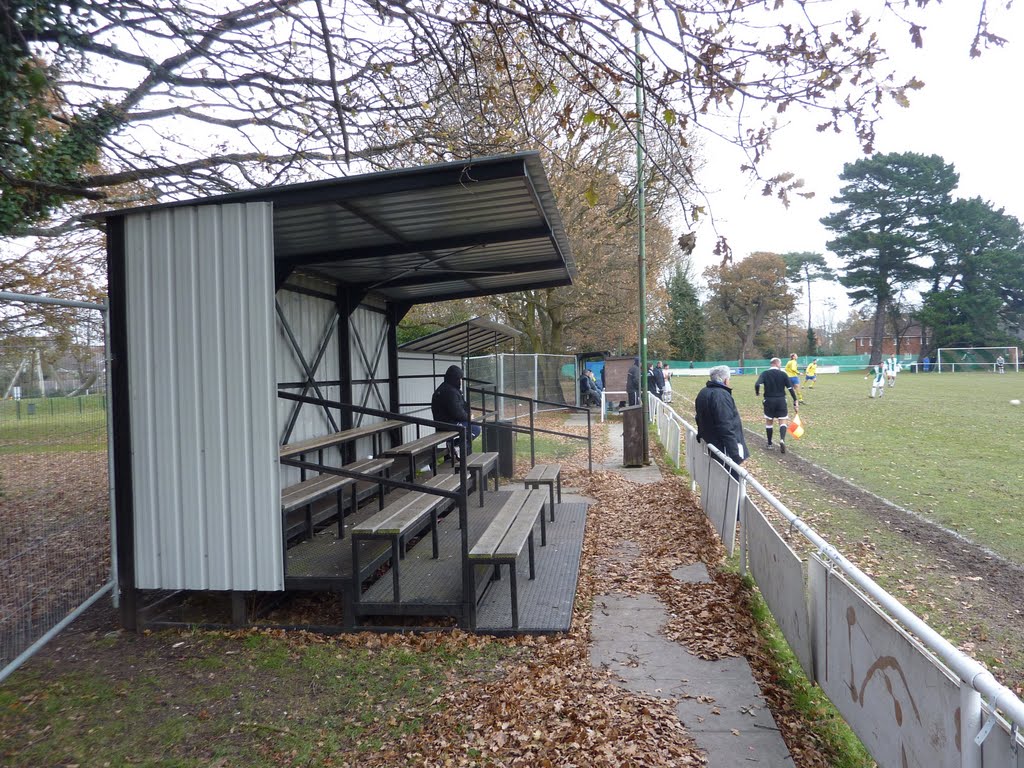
[469,490,545,630]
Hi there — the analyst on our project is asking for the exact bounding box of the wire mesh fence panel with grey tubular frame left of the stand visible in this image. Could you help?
[0,293,114,681]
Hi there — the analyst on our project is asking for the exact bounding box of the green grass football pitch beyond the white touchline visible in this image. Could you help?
[672,371,1024,563]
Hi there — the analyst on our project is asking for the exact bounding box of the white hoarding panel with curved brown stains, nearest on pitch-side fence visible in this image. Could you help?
[809,555,962,768]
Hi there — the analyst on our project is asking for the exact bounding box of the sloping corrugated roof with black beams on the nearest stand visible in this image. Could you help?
[97,152,575,304]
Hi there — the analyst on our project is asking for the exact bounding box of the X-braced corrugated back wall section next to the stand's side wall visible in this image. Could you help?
[275,274,341,487]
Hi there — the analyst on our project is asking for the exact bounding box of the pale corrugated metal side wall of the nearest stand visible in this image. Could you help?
[125,203,284,591]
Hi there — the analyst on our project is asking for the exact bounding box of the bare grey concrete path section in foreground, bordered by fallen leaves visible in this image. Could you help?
[591,595,793,768]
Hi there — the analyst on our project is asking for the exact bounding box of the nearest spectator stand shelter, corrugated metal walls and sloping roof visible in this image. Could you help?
[103,153,575,627]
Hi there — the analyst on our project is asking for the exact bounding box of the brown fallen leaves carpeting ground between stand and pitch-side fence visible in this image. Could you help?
[0,423,831,768]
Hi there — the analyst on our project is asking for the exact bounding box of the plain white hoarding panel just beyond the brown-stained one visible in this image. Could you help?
[743,497,814,680]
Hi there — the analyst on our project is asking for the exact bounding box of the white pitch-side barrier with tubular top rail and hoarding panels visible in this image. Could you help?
[650,397,1024,768]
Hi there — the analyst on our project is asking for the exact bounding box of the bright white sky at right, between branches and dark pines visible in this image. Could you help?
[693,0,1024,322]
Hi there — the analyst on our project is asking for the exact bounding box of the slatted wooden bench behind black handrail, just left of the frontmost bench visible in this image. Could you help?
[351,474,462,603]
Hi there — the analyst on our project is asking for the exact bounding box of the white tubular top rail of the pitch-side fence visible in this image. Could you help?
[657,401,1024,724]
